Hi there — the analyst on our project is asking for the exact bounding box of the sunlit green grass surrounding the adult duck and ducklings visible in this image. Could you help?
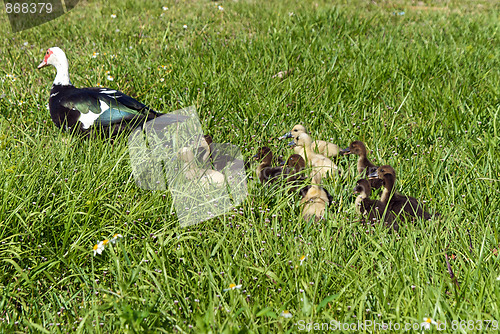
[0,0,500,333]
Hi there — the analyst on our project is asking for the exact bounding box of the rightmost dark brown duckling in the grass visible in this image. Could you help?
[369,165,432,220]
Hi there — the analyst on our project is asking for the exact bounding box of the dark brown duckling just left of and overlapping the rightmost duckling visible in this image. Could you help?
[354,179,399,232]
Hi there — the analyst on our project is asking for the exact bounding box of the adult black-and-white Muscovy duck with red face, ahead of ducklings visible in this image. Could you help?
[38,47,188,136]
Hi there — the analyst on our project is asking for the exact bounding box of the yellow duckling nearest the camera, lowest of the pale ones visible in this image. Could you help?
[300,174,333,222]
